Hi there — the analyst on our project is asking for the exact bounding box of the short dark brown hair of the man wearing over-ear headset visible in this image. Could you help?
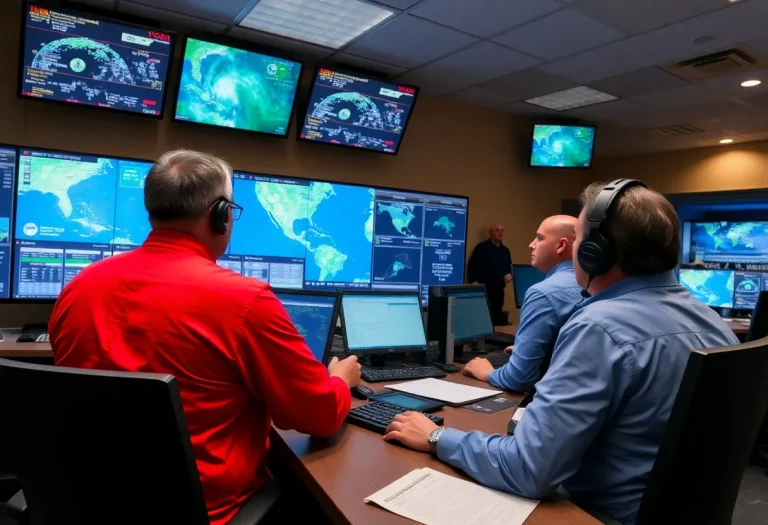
[581,182,680,275]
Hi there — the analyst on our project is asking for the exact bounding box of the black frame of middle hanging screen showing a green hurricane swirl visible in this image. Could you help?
[171,35,305,139]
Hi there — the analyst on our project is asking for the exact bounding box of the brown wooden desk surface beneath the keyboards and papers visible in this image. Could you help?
[272,374,599,525]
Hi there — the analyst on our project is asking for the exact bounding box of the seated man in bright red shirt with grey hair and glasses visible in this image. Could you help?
[49,150,360,525]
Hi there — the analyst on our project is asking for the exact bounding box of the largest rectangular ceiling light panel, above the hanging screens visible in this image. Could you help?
[240,0,394,49]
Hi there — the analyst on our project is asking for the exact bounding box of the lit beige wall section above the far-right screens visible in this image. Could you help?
[585,142,768,193]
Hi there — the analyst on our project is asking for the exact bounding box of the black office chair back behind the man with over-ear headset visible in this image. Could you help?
[637,338,768,525]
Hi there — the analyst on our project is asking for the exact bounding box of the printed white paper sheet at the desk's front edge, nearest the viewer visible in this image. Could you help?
[363,468,539,525]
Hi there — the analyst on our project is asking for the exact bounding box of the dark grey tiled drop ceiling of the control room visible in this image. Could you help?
[79,0,768,155]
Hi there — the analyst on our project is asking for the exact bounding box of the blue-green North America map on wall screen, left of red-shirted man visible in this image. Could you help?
[16,151,117,243]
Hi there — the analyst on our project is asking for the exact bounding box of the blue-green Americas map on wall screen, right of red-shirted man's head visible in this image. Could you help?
[230,174,374,283]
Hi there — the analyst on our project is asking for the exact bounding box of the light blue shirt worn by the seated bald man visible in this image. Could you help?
[488,261,582,392]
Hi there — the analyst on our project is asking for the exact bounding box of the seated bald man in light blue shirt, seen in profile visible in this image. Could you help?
[464,215,582,392]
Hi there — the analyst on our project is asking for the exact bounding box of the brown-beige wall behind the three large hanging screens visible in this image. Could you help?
[0,1,580,326]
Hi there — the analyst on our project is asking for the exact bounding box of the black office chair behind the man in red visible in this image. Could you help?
[0,359,279,525]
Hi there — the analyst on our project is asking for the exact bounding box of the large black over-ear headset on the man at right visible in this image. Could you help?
[578,179,648,281]
